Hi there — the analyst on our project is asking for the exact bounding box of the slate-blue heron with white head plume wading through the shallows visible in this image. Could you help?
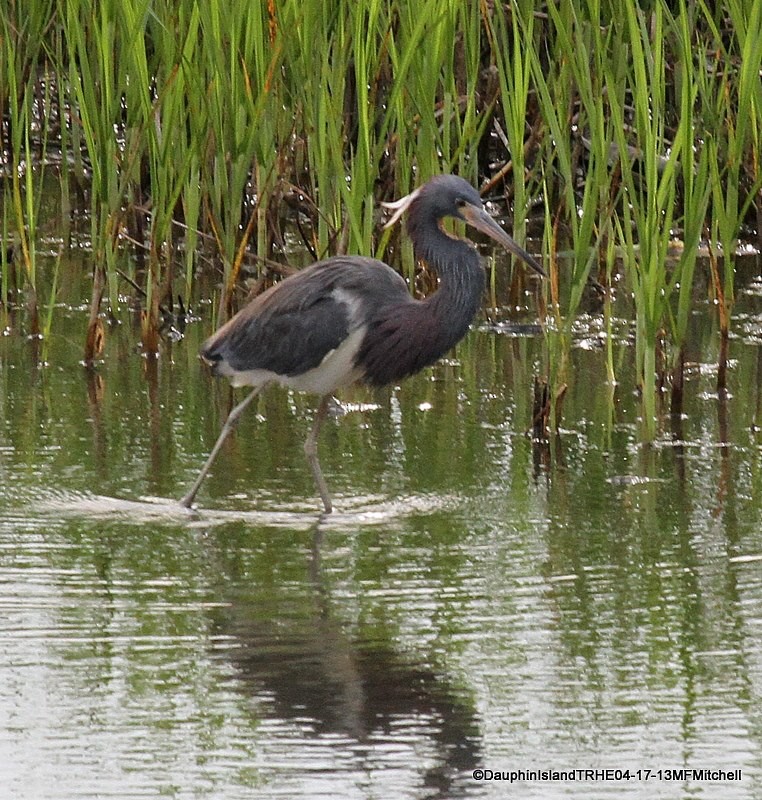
[181,175,545,513]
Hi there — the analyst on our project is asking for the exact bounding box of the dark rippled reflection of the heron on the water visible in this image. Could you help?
[208,533,481,800]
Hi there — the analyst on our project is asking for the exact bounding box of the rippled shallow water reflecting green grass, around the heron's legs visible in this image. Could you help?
[0,264,762,800]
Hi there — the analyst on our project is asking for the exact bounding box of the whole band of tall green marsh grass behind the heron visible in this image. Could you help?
[0,0,762,438]
